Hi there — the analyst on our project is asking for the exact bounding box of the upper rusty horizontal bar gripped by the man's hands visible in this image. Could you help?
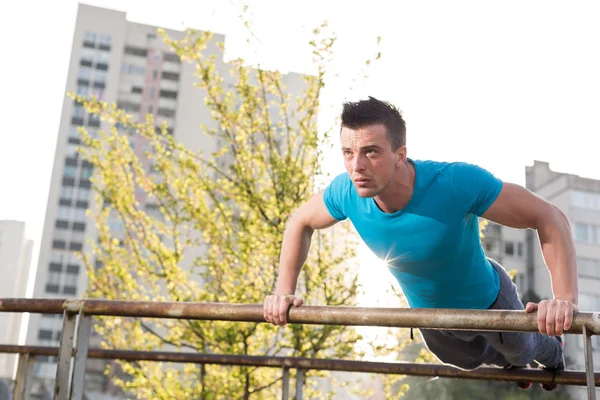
[0,299,600,334]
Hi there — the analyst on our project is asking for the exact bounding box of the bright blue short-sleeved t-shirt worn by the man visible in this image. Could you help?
[324,160,502,309]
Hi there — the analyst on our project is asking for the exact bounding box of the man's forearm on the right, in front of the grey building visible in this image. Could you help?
[538,209,579,304]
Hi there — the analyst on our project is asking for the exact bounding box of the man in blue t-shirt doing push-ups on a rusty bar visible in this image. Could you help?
[264,97,578,390]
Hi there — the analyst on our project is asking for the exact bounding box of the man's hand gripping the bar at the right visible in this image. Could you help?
[525,298,578,336]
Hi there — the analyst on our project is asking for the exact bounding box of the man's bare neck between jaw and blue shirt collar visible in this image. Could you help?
[374,160,416,214]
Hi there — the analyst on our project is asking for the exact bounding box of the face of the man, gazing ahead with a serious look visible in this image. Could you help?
[341,124,404,197]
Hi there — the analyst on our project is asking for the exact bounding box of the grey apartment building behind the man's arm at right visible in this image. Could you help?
[484,161,600,399]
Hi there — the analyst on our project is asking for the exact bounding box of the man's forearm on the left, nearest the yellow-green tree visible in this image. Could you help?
[275,220,314,294]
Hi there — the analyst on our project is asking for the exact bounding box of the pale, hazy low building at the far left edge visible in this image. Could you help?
[0,221,33,379]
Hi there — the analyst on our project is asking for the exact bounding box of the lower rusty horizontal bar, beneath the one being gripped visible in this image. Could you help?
[0,345,600,386]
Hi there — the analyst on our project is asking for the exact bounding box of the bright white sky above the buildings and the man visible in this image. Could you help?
[0,0,600,306]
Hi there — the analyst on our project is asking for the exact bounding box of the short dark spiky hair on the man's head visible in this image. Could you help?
[342,96,406,151]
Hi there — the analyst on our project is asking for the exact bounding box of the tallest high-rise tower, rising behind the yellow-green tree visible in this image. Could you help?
[27,4,305,393]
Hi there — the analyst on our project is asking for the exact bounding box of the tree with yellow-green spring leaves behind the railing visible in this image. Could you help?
[73,13,390,399]
